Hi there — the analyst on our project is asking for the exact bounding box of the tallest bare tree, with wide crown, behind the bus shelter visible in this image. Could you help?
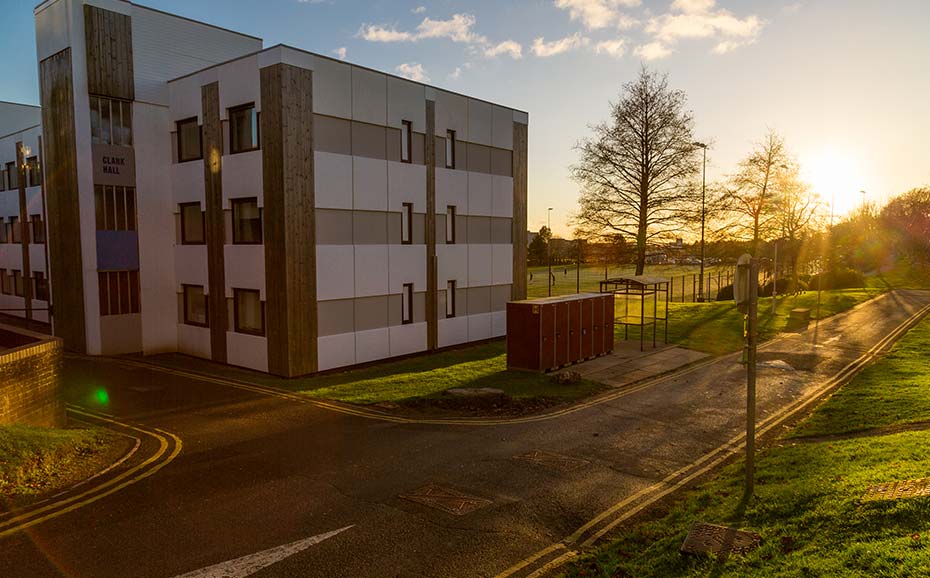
[571,67,698,275]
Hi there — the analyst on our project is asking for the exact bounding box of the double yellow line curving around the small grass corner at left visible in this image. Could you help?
[0,405,183,538]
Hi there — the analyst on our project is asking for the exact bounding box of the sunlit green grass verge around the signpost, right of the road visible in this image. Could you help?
[565,319,930,578]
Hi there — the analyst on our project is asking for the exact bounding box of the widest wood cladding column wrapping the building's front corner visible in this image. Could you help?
[260,64,320,377]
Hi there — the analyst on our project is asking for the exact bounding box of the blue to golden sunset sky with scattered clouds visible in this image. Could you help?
[0,0,930,237]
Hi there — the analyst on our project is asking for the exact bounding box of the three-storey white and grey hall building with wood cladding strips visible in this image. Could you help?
[25,0,528,376]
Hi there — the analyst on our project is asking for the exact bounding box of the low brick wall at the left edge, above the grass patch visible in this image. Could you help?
[0,326,65,427]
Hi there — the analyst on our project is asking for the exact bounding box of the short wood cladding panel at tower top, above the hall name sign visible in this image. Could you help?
[84,4,135,100]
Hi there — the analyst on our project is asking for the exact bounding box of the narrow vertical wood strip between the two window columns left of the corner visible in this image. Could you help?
[201,82,228,363]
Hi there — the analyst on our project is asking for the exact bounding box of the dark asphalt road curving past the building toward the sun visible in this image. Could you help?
[0,291,930,578]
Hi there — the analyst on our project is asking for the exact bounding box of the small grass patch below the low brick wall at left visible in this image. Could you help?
[0,425,114,499]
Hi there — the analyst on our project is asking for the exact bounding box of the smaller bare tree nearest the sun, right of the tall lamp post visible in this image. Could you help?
[721,131,789,255]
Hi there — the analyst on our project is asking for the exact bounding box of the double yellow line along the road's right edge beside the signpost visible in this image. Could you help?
[495,305,930,578]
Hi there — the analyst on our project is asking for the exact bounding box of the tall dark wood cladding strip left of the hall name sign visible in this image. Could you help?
[39,48,87,353]
